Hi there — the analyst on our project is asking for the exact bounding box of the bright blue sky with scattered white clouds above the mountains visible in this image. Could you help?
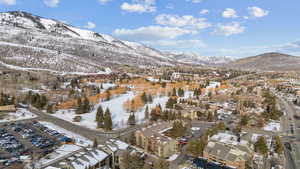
[0,0,300,57]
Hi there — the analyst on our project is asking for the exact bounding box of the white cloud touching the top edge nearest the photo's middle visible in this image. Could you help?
[121,0,156,13]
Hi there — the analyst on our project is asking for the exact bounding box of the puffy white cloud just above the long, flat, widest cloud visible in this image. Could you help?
[155,14,211,30]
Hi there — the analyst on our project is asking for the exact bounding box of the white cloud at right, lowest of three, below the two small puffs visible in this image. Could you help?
[213,22,246,36]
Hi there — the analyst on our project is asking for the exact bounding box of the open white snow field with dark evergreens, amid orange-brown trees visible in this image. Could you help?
[53,91,168,129]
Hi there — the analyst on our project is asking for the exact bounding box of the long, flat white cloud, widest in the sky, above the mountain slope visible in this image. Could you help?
[113,26,194,42]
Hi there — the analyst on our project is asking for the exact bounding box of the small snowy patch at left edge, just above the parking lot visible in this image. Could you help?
[0,108,37,123]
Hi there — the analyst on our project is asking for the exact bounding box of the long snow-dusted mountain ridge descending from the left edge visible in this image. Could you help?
[0,11,231,72]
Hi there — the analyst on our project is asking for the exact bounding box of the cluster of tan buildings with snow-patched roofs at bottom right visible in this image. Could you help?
[182,129,284,169]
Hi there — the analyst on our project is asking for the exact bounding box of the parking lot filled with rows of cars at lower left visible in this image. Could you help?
[0,121,73,168]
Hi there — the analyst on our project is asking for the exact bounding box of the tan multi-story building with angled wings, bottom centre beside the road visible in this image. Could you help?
[135,122,178,158]
